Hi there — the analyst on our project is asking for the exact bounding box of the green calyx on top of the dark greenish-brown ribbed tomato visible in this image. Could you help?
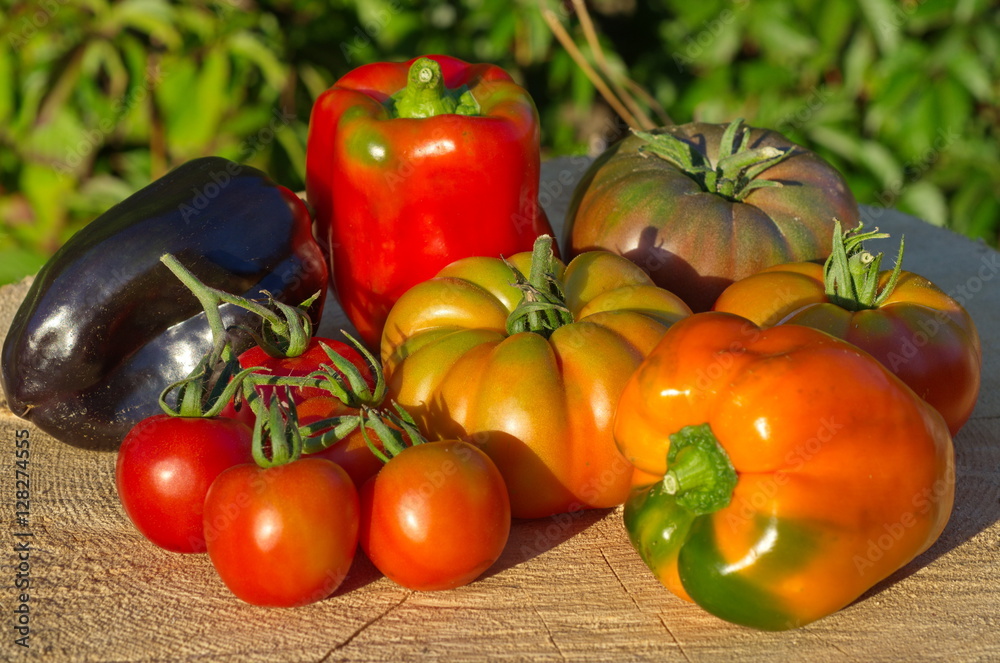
[633,118,793,202]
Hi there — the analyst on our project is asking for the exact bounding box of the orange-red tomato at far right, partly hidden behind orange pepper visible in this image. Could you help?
[715,226,982,435]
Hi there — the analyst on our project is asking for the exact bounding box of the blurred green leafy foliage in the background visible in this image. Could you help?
[0,0,1000,283]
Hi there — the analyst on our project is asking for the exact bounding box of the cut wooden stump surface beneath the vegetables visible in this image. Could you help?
[0,159,1000,661]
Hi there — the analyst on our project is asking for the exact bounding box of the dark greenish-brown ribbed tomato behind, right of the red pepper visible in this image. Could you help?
[562,120,858,311]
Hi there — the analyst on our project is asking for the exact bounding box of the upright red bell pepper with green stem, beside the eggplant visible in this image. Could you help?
[306,55,552,347]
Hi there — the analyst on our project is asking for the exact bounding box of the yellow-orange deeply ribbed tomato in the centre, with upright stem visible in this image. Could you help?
[382,236,690,518]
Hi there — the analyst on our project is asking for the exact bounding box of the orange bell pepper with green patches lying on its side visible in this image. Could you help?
[614,312,955,630]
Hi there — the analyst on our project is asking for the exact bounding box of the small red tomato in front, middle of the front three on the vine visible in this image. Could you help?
[204,458,359,607]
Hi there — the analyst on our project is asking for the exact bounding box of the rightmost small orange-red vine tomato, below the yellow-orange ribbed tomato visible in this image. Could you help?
[360,440,510,591]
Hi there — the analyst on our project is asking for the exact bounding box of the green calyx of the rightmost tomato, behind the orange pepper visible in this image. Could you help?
[823,219,905,311]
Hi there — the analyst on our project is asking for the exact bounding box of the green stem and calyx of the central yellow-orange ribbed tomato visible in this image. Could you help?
[504,235,573,338]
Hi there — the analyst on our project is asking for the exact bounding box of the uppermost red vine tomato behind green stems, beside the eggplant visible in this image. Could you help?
[222,337,375,427]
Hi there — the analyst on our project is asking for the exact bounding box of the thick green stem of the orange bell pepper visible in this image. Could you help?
[661,424,737,515]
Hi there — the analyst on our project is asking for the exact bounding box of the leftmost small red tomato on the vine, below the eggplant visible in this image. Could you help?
[115,414,253,552]
